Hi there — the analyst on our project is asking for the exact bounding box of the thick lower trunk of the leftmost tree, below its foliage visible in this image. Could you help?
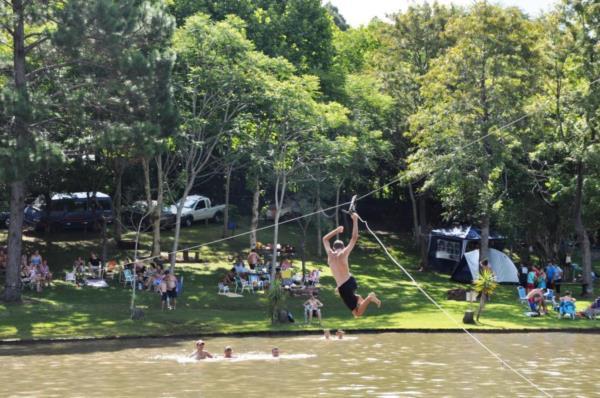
[2,181,25,302]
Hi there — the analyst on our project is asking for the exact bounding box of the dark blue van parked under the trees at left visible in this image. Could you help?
[24,192,113,230]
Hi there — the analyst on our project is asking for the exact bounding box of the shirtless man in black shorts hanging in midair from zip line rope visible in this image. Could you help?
[323,212,381,318]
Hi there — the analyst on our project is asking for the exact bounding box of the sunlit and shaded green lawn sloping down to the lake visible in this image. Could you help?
[0,224,600,339]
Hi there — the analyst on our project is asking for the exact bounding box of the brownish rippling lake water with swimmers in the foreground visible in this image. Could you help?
[0,333,600,398]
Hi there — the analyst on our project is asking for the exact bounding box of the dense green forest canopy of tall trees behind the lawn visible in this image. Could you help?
[0,0,600,301]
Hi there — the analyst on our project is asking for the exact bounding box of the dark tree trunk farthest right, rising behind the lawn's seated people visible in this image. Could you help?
[575,161,594,297]
